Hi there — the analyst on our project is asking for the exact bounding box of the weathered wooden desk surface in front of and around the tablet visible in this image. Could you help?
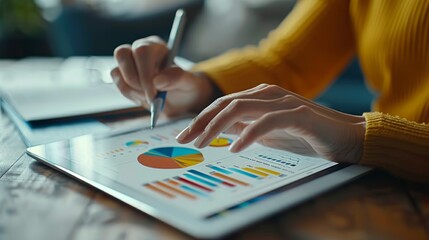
[0,114,429,240]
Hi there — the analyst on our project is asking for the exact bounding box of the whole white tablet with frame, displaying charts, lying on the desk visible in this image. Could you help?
[27,119,370,238]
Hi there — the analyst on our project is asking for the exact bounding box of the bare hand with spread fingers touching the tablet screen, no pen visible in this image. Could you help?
[177,84,365,163]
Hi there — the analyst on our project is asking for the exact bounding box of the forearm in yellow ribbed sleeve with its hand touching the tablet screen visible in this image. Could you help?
[177,84,429,183]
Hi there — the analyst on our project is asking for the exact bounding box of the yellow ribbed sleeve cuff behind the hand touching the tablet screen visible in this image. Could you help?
[360,112,429,182]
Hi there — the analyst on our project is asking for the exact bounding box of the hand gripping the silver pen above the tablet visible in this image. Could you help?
[111,36,215,116]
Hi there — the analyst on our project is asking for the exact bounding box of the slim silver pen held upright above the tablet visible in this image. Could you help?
[150,9,185,128]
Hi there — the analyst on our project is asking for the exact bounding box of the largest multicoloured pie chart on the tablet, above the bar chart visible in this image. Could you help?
[137,147,204,169]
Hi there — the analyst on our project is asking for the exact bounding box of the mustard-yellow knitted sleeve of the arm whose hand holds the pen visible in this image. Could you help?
[193,0,355,98]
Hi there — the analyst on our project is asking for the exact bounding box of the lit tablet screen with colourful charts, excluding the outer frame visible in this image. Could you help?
[28,120,336,218]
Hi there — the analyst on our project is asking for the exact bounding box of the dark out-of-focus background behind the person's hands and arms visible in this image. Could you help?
[0,0,372,113]
